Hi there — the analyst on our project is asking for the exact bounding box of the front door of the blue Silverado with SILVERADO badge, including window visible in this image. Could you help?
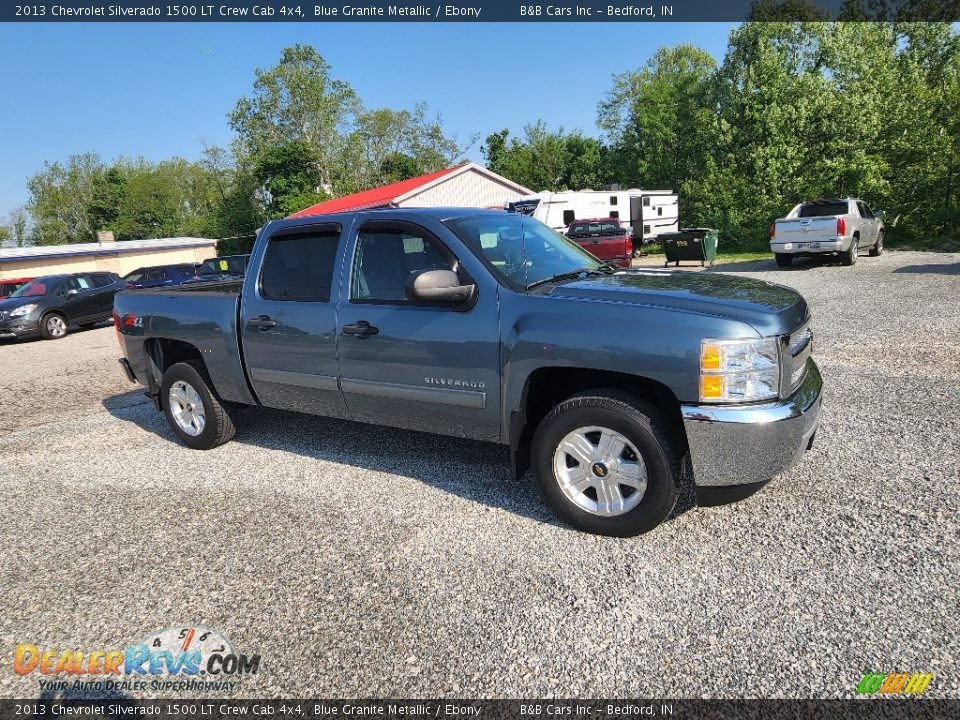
[338,220,500,440]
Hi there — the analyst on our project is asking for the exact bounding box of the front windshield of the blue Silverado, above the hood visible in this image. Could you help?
[445,213,602,290]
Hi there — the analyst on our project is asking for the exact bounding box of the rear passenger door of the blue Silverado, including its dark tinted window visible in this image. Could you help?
[240,223,347,418]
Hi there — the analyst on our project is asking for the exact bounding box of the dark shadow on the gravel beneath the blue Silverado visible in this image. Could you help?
[103,391,696,526]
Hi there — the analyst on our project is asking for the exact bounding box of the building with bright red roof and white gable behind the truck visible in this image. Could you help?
[290,163,531,217]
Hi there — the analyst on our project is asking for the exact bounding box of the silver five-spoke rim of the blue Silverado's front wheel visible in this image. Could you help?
[553,426,647,517]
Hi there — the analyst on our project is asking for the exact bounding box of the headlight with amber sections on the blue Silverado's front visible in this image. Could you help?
[700,338,780,402]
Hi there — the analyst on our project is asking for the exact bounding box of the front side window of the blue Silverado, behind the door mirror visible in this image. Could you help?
[350,229,455,303]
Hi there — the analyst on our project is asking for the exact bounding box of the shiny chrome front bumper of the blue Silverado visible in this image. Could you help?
[680,359,823,488]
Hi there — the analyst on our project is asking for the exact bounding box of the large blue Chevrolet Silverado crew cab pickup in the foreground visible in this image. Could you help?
[114,208,821,536]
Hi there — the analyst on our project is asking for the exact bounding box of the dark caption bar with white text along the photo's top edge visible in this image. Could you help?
[0,0,960,23]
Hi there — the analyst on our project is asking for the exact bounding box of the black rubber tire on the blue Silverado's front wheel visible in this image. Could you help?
[532,390,681,537]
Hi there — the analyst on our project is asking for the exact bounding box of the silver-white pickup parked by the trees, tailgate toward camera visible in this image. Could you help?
[770,198,884,267]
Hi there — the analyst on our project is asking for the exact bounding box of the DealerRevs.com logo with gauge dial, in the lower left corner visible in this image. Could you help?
[13,625,260,692]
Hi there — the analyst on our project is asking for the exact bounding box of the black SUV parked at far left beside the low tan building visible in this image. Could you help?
[0,272,125,340]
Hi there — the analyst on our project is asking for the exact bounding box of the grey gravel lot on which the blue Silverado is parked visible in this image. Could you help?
[0,252,960,697]
